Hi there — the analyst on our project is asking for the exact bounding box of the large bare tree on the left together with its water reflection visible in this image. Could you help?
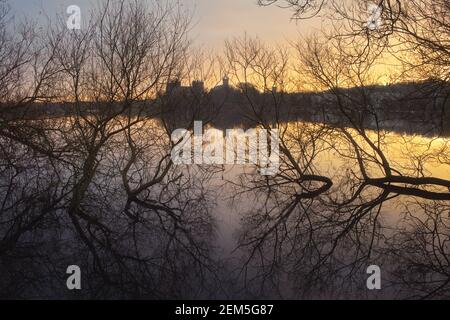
[0,1,221,298]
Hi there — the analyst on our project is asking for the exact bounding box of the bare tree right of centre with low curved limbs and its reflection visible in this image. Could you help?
[221,31,449,297]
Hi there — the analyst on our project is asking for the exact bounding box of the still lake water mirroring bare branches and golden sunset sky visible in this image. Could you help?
[0,118,450,299]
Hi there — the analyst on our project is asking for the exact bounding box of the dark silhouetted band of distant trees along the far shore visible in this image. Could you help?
[0,81,450,136]
